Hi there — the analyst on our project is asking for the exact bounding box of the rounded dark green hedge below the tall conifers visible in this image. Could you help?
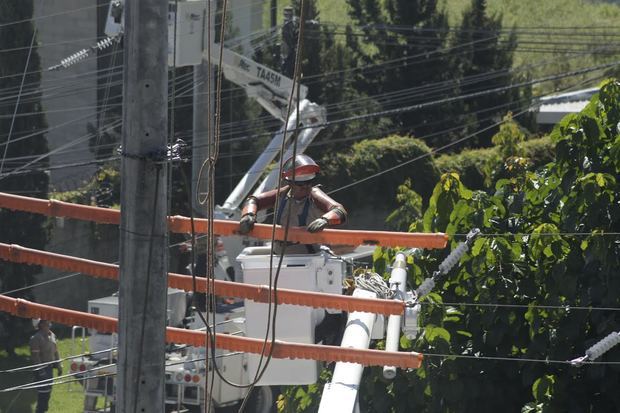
[320,135,553,209]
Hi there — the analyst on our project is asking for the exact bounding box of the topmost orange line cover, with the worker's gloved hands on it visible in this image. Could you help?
[0,193,448,248]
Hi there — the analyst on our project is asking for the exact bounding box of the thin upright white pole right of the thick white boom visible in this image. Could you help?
[383,252,407,379]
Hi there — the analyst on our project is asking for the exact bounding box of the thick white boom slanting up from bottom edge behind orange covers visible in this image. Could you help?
[319,288,377,413]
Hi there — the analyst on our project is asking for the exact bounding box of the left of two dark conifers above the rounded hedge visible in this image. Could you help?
[347,0,454,142]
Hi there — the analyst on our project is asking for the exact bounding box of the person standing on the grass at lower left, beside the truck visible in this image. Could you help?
[30,318,62,413]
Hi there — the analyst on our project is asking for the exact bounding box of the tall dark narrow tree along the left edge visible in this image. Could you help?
[0,0,48,352]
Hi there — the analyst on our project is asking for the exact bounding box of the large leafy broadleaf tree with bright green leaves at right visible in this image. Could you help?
[360,81,620,412]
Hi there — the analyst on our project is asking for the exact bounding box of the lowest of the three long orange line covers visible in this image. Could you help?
[0,295,423,368]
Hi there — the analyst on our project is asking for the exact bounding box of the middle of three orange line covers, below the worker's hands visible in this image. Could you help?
[0,243,405,315]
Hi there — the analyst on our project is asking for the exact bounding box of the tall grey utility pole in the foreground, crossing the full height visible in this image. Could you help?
[116,0,168,413]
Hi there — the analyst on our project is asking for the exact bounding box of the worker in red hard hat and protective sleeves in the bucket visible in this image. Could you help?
[239,155,347,254]
